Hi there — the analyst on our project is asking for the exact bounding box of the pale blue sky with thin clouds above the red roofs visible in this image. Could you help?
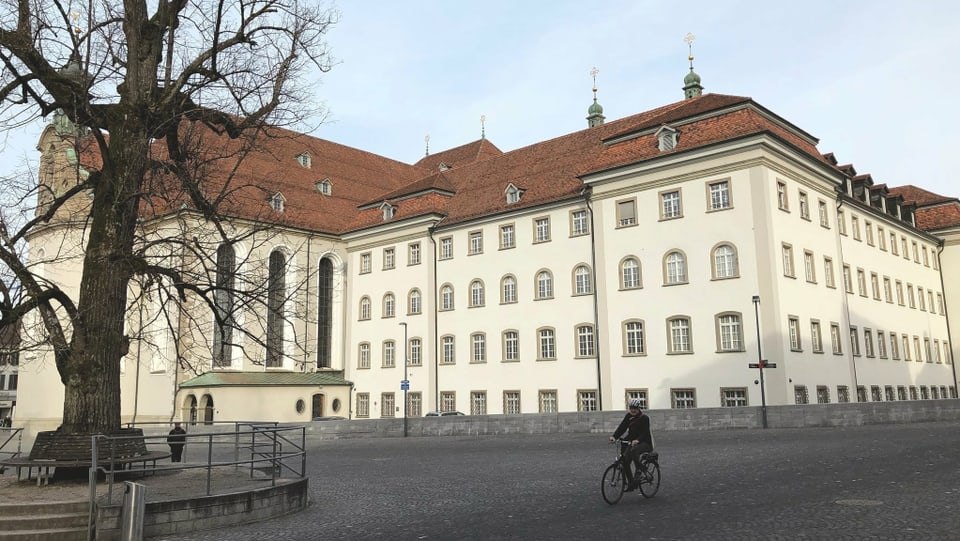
[0,0,960,197]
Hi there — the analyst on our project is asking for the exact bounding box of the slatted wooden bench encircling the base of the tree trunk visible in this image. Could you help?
[0,428,170,486]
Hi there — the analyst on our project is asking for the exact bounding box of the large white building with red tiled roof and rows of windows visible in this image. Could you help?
[16,66,960,430]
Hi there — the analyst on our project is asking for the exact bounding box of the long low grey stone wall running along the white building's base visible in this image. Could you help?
[307,399,960,439]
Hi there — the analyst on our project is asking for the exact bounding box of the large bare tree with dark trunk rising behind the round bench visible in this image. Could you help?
[0,0,337,433]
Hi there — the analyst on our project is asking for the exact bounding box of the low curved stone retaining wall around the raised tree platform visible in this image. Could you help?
[97,478,309,541]
